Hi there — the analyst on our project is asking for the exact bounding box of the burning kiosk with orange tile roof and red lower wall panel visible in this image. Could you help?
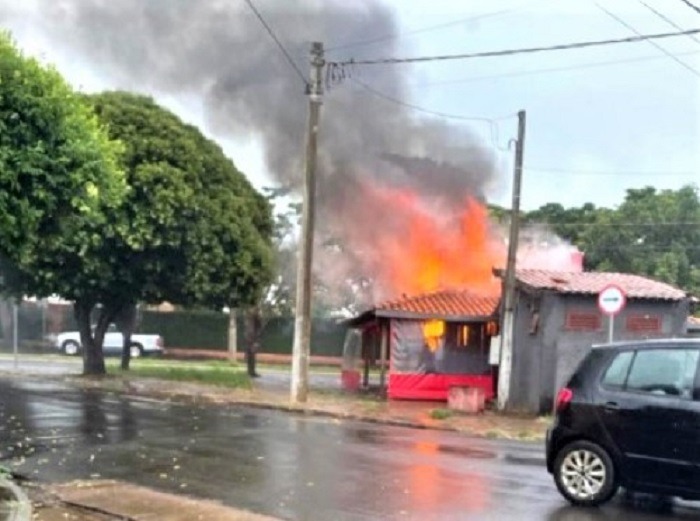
[342,290,500,400]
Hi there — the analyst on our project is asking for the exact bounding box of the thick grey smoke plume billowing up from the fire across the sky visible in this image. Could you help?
[0,0,504,308]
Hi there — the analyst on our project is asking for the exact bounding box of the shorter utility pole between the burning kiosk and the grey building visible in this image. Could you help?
[498,110,525,410]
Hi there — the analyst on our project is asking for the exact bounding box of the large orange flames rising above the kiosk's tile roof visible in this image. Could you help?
[352,181,506,297]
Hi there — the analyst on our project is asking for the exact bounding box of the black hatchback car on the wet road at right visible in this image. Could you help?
[547,339,700,506]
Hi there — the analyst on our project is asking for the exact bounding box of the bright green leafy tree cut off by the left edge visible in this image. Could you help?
[0,34,129,374]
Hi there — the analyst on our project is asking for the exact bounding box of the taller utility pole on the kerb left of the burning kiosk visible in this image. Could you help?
[290,42,325,403]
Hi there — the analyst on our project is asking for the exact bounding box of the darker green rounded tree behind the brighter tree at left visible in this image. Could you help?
[82,92,274,368]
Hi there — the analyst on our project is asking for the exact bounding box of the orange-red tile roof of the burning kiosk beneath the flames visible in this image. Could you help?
[375,290,500,319]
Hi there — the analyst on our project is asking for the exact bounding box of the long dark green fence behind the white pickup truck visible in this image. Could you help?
[0,300,346,356]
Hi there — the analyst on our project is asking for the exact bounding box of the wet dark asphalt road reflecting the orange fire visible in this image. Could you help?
[0,380,700,521]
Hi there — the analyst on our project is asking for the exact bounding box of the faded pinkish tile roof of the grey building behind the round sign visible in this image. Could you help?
[516,270,687,300]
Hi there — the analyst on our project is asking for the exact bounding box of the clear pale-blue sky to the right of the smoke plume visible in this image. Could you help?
[372,0,700,209]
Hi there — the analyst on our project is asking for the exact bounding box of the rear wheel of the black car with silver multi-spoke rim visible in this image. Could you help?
[554,441,618,506]
